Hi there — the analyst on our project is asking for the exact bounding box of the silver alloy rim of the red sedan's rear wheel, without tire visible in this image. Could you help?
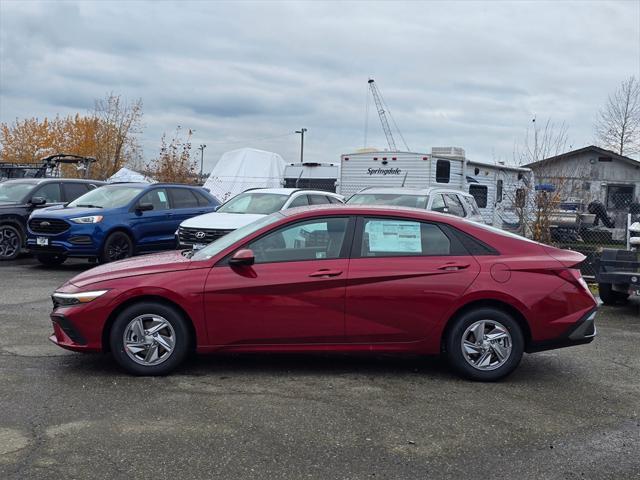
[461,320,512,371]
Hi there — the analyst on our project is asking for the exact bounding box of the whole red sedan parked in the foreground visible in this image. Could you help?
[51,206,597,380]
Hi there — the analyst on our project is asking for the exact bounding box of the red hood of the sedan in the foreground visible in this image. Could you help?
[69,250,191,287]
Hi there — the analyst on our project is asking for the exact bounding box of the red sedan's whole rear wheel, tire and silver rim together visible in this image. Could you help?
[445,308,524,381]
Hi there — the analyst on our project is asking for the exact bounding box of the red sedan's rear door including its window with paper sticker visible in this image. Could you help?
[345,218,480,343]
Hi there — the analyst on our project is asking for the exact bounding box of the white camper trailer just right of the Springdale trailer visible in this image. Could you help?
[465,160,533,230]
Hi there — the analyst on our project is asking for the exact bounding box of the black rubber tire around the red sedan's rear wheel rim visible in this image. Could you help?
[445,307,524,382]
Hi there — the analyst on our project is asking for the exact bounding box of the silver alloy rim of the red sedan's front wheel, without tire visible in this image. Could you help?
[123,314,176,366]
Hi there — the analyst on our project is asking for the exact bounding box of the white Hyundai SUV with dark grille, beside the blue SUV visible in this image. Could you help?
[176,188,344,249]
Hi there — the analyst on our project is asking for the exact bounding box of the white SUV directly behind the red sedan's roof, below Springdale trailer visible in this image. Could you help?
[347,187,484,223]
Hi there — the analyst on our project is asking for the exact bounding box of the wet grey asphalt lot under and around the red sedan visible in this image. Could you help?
[0,259,640,479]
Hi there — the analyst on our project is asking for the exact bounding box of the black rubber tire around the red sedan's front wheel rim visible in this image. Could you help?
[109,302,192,376]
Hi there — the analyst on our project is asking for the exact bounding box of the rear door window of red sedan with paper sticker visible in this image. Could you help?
[360,218,451,257]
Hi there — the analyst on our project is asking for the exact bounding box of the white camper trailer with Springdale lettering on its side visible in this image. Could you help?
[338,149,465,198]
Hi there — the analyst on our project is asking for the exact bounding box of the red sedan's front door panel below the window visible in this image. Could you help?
[205,259,348,345]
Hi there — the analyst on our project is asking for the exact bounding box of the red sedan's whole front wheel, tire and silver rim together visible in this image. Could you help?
[109,302,191,375]
